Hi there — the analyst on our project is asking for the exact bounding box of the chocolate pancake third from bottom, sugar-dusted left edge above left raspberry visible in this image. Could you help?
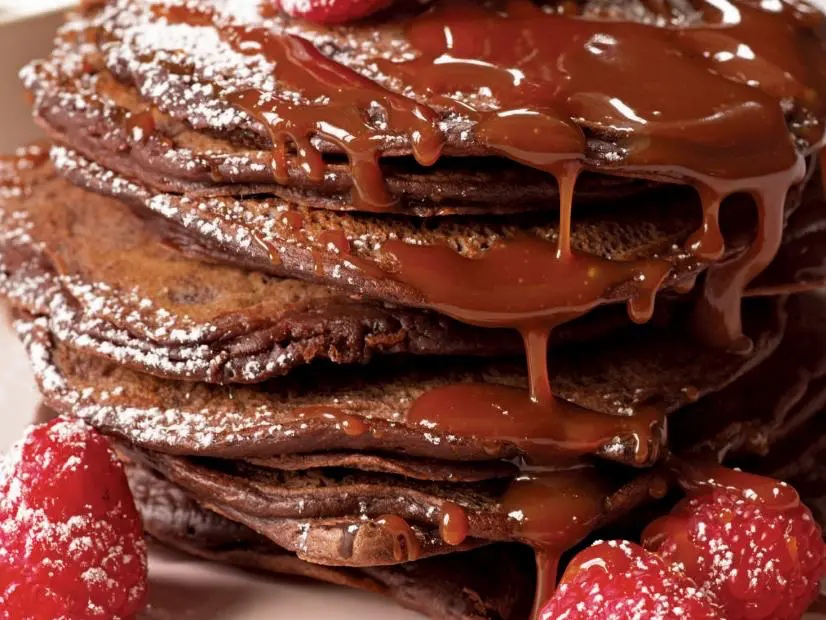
[14,290,782,462]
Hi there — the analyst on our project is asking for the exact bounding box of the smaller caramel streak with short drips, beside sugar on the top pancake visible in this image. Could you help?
[154,5,443,210]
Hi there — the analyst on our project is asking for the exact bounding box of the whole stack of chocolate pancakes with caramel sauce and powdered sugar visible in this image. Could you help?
[0,0,826,620]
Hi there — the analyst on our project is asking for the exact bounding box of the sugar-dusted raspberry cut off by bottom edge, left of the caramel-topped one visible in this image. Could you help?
[540,540,720,620]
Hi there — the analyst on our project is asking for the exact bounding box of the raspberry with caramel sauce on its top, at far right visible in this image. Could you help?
[643,471,826,620]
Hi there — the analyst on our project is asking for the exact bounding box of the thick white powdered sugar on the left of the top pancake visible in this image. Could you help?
[21,0,438,171]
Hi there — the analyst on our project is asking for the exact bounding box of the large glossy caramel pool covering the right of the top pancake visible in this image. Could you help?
[383,0,826,347]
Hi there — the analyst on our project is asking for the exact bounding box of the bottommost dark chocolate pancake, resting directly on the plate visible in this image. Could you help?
[127,464,535,620]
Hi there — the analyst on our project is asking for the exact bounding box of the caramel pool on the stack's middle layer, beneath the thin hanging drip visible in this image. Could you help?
[383,237,670,329]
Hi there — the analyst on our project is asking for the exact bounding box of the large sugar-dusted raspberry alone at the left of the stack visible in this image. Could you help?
[0,418,147,620]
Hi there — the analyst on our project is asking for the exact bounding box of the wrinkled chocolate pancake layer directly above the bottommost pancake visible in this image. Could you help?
[128,444,658,566]
